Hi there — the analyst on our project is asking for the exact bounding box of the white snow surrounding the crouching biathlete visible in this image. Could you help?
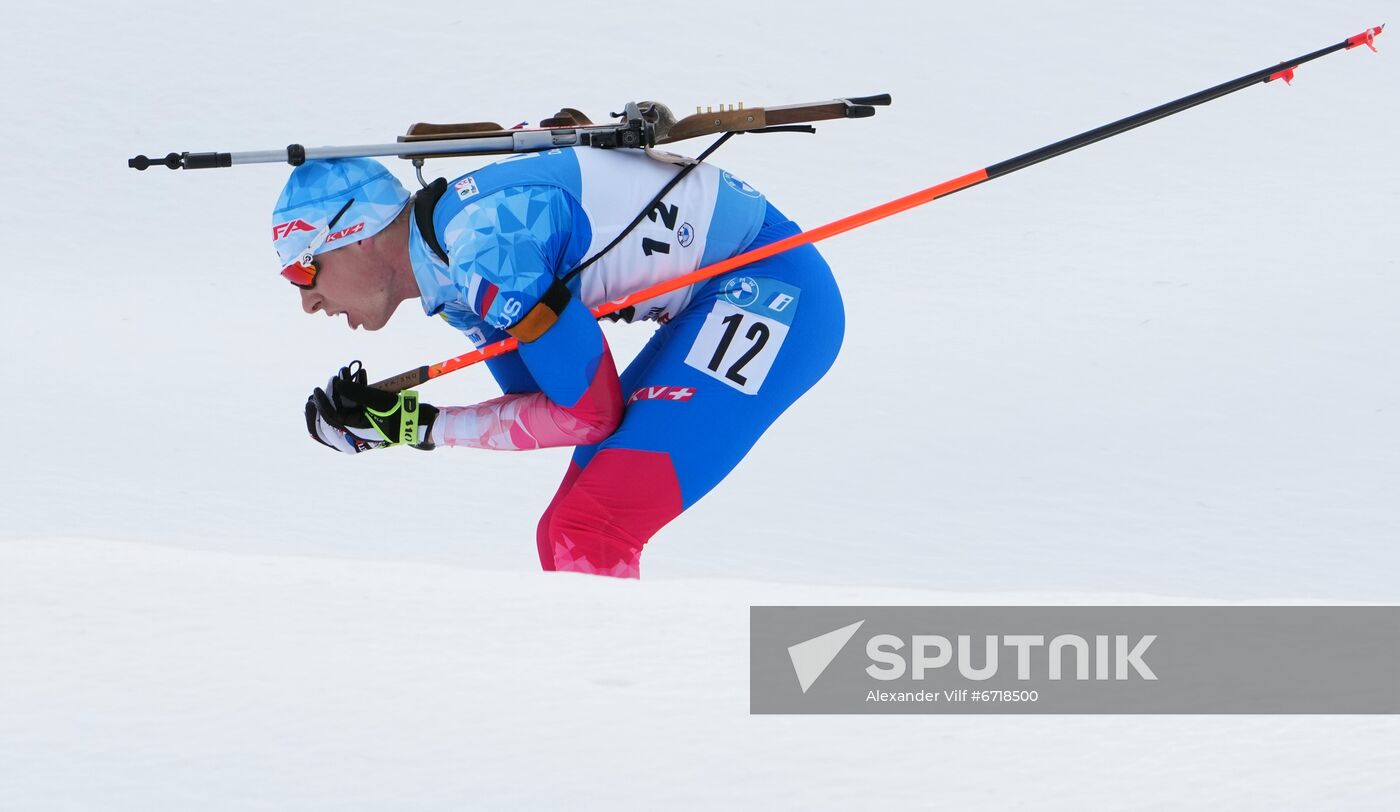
[0,0,1400,811]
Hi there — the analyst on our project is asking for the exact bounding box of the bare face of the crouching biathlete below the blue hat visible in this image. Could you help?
[300,237,399,330]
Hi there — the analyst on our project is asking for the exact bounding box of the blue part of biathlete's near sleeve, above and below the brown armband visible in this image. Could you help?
[444,186,603,407]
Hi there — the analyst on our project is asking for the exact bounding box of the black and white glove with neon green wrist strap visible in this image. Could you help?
[305,361,437,454]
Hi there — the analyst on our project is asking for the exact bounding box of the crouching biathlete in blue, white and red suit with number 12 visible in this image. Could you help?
[273,148,844,578]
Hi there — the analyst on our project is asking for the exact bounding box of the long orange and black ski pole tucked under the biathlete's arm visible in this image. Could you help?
[374,25,1385,392]
